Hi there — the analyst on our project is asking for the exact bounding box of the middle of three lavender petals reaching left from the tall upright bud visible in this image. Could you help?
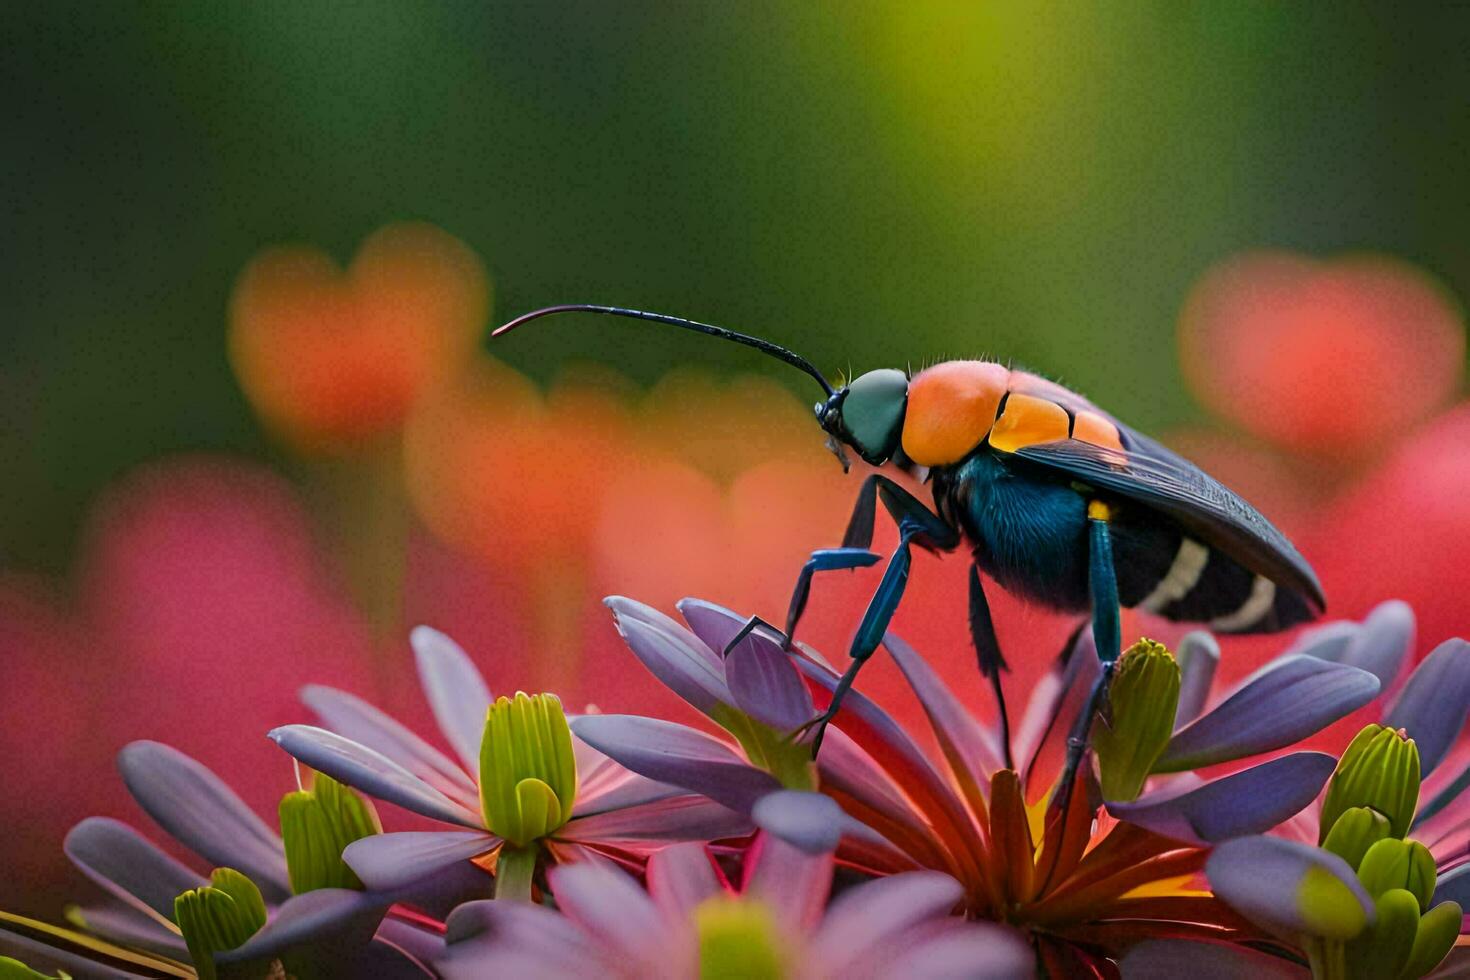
[268,724,484,830]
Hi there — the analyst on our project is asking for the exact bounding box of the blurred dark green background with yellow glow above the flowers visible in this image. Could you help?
[0,1,1470,570]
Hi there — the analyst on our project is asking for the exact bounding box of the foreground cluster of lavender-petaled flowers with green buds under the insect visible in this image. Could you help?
[0,598,1470,980]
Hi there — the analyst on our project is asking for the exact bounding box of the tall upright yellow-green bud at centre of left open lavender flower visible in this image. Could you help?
[479,691,576,846]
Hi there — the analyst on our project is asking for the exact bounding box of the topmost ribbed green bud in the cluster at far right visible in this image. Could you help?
[1317,724,1419,843]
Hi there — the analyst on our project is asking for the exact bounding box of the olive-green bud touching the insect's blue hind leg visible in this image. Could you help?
[1092,639,1179,801]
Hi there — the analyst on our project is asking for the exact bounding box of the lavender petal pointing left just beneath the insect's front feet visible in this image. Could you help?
[572,714,781,813]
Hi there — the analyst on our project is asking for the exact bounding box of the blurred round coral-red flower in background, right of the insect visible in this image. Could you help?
[1179,251,1466,460]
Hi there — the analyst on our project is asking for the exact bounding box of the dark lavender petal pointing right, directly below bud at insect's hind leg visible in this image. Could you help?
[1107,752,1336,846]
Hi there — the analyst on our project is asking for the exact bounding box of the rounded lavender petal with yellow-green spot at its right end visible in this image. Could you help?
[1205,837,1374,942]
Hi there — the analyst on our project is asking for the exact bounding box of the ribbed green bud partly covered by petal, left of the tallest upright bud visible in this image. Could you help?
[278,773,381,895]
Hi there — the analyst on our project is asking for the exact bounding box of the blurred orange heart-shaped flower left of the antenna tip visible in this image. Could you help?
[229,223,490,451]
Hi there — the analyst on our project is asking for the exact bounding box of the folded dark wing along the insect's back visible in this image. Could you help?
[1016,425,1327,614]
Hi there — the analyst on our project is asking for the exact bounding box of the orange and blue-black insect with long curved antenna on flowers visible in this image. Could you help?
[494,306,1324,805]
